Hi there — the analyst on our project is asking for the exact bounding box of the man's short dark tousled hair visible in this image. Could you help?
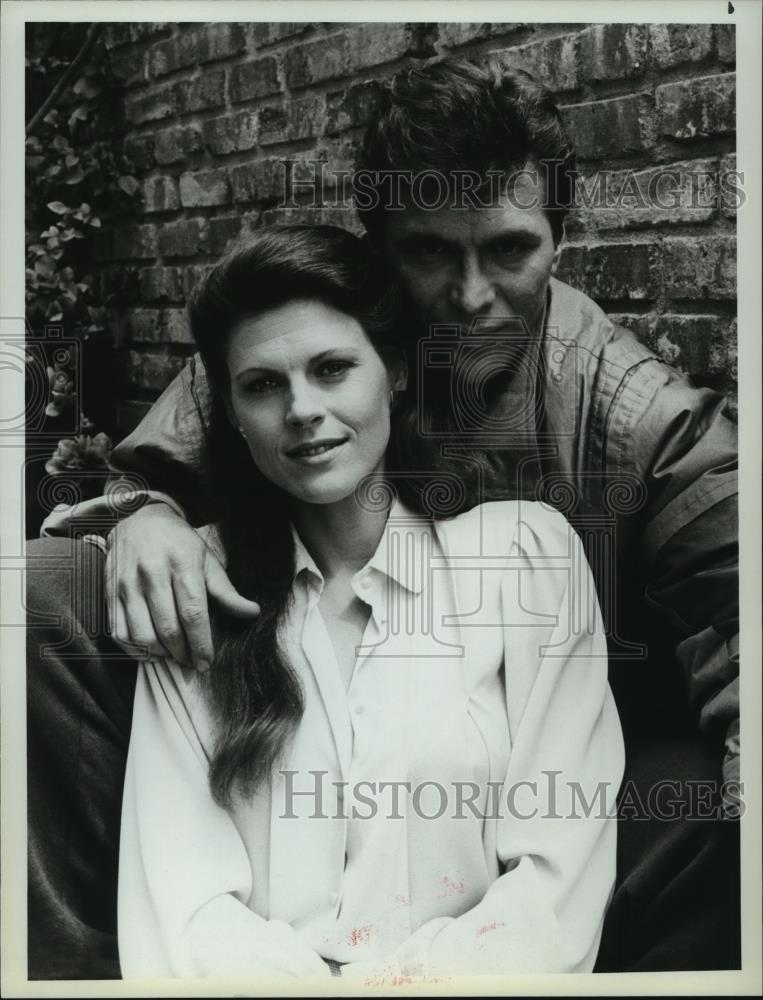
[356,59,575,242]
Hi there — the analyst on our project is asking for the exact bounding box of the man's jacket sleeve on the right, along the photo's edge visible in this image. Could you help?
[618,361,739,802]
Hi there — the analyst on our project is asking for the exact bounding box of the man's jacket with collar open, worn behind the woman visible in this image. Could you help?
[43,279,739,782]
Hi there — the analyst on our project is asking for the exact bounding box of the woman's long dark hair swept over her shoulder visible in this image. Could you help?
[188,226,430,806]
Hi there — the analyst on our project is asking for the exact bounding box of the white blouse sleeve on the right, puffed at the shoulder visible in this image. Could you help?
[343,504,624,981]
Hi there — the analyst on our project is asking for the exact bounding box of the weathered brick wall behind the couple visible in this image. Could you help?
[98,23,736,431]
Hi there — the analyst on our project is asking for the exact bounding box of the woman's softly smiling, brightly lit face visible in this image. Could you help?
[227,300,392,504]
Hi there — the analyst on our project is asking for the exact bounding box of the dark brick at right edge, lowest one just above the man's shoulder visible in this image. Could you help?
[654,314,736,382]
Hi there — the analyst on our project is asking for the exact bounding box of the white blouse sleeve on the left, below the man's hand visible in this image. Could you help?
[119,661,330,978]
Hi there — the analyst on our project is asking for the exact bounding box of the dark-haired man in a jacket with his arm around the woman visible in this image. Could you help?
[28,56,739,977]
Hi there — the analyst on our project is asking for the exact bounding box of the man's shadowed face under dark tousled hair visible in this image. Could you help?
[384,169,556,336]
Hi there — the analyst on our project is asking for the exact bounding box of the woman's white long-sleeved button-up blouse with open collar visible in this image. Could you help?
[119,502,623,985]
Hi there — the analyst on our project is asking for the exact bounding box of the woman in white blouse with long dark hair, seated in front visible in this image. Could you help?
[119,227,623,983]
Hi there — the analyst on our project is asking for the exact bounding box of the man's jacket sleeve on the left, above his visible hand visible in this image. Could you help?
[41,356,214,537]
